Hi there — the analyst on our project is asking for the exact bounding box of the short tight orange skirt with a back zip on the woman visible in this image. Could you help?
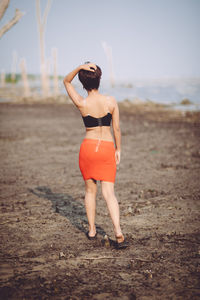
[79,139,116,182]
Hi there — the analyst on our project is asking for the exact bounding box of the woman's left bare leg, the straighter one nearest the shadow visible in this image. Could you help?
[85,179,97,237]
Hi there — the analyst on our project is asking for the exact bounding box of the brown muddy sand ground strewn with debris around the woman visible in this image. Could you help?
[0,103,200,300]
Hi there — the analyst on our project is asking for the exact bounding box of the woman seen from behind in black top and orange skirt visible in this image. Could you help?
[64,63,127,248]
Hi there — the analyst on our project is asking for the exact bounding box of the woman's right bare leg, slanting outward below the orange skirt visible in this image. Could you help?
[101,181,122,242]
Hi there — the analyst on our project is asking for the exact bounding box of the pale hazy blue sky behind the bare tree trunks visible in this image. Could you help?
[0,0,200,81]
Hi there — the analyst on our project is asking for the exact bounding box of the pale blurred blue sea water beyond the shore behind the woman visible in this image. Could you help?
[62,78,200,110]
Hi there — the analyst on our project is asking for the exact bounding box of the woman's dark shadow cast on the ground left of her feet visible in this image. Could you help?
[29,186,106,236]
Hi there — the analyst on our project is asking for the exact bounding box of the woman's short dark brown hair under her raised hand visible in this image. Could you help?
[78,65,102,91]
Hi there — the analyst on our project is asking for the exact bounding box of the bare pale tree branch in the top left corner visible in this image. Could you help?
[0,0,24,38]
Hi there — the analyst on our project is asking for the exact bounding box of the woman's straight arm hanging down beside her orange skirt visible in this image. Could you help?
[112,98,121,165]
